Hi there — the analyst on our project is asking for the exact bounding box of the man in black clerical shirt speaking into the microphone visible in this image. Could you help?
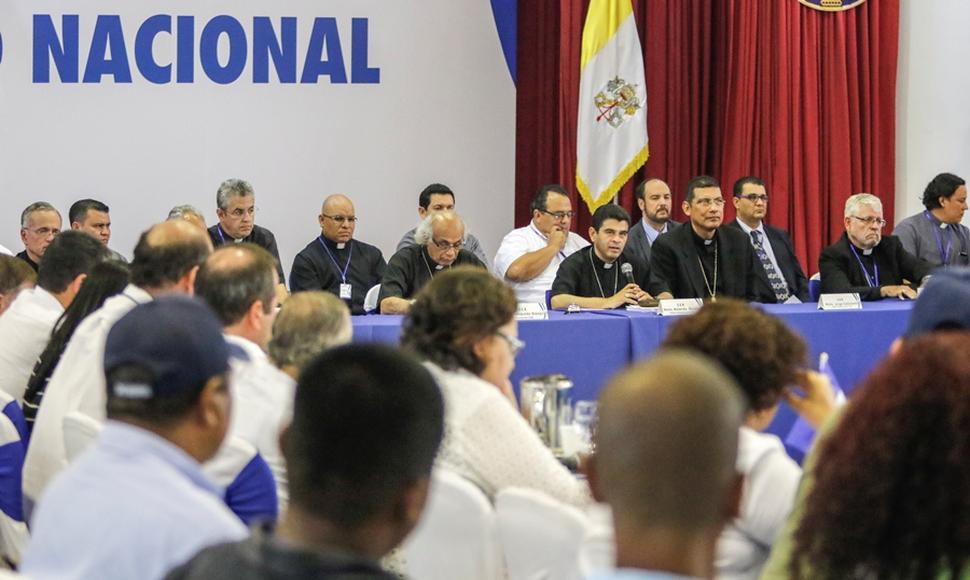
[550,203,650,310]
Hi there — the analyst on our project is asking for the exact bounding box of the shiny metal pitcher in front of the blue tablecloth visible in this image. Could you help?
[519,375,573,454]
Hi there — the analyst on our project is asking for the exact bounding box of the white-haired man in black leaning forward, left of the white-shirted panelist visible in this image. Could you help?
[377,212,485,314]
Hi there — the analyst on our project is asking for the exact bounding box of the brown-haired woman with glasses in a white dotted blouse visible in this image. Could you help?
[401,268,590,505]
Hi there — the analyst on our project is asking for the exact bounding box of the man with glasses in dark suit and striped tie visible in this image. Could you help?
[728,176,811,302]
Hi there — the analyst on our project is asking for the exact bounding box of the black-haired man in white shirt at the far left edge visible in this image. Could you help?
[0,231,108,401]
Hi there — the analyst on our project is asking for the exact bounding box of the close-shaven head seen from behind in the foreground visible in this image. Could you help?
[589,350,746,578]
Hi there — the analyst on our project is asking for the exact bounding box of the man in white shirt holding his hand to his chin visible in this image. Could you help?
[495,184,589,303]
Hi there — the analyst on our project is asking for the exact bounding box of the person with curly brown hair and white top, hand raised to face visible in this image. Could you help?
[662,300,834,580]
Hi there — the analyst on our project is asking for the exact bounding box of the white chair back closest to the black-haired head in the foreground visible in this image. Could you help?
[403,470,504,580]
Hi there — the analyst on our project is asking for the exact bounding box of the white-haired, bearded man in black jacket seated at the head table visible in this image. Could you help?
[818,193,933,300]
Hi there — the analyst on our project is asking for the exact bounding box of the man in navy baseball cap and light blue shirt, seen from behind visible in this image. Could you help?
[22,296,246,579]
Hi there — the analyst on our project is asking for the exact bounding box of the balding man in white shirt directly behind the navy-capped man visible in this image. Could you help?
[23,221,212,508]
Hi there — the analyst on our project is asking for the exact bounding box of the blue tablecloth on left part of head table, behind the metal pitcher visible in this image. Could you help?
[353,312,631,400]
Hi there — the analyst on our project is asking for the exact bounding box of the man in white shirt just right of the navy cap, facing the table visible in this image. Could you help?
[195,243,296,507]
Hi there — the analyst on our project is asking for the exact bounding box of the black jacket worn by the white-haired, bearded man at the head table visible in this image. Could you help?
[818,232,933,300]
